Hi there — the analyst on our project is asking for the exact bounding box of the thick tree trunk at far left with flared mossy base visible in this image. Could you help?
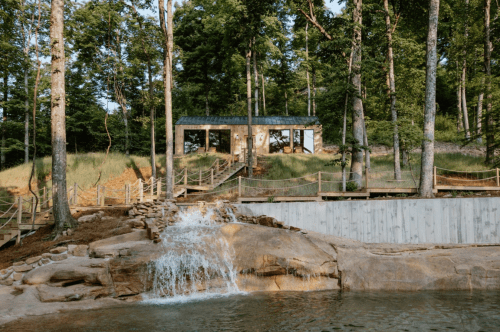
[50,0,76,236]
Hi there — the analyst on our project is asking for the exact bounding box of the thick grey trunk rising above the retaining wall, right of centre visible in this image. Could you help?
[420,0,439,198]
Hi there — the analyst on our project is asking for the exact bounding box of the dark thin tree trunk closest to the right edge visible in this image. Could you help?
[484,0,495,164]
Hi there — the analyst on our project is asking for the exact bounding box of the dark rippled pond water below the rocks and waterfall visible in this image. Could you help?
[0,291,500,332]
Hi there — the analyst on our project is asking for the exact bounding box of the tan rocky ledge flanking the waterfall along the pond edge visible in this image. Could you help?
[0,198,500,323]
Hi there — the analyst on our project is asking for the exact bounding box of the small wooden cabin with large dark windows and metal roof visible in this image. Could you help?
[175,116,323,155]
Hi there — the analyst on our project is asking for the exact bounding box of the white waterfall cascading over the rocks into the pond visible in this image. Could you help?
[145,207,239,302]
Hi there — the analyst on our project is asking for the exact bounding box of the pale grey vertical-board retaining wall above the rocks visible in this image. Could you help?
[236,197,500,243]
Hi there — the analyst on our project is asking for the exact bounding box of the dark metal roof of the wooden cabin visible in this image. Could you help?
[175,116,320,125]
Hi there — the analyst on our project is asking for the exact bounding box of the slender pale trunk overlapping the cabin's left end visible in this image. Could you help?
[158,0,174,199]
